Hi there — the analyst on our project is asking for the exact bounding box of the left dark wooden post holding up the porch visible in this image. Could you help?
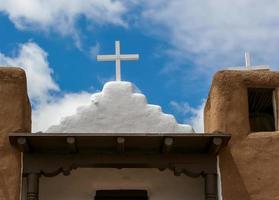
[27,173,40,200]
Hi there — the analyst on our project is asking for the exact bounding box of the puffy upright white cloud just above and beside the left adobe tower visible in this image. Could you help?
[0,42,59,104]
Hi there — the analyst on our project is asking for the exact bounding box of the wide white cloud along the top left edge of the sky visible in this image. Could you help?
[0,0,127,35]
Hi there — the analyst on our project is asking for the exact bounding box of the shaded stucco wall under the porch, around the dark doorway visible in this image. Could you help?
[23,168,204,200]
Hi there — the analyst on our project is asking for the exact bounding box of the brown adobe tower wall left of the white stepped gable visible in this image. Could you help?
[0,67,31,200]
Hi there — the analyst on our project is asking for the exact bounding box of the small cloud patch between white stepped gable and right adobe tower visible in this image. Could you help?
[170,99,206,133]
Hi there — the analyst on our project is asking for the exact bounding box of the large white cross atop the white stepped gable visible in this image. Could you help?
[97,41,139,81]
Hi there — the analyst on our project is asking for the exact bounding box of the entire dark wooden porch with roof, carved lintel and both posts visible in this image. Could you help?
[9,133,230,200]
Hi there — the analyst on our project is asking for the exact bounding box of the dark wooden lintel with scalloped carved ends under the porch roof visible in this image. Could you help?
[24,152,217,177]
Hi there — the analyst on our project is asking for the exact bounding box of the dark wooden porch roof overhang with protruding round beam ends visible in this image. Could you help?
[9,133,230,154]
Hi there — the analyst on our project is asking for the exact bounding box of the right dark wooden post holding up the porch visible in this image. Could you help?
[204,174,217,200]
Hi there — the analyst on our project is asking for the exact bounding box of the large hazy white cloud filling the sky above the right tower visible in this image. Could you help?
[141,0,279,72]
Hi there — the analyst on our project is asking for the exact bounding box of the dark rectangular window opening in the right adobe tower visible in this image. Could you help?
[248,88,276,132]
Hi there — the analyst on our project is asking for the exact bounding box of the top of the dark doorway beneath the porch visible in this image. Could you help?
[95,190,148,200]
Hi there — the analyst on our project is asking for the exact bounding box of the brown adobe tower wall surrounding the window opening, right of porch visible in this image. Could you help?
[204,71,279,200]
